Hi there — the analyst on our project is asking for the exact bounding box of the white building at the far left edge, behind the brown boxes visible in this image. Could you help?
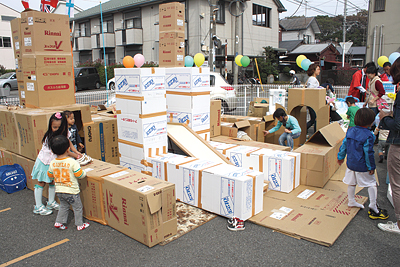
[0,4,21,69]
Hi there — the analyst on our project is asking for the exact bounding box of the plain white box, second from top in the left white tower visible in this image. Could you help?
[115,91,167,115]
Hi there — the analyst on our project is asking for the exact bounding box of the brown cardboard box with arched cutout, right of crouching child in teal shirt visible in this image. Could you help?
[288,88,329,146]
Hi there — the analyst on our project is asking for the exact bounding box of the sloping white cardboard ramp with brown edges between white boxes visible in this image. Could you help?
[167,123,232,165]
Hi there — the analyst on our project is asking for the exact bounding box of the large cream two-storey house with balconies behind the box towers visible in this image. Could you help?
[72,0,286,71]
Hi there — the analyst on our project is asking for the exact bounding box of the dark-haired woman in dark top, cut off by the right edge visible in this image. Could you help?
[378,58,400,234]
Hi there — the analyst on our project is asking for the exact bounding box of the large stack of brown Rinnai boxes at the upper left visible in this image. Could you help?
[11,10,75,108]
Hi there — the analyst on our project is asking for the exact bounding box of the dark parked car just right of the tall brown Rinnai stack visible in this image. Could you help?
[74,67,101,92]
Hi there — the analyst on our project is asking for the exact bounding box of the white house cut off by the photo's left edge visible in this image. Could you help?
[0,3,21,69]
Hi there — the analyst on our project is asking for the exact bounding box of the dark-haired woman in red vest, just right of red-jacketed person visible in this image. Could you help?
[364,66,385,115]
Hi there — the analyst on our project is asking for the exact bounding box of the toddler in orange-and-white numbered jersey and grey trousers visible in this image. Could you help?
[47,135,89,231]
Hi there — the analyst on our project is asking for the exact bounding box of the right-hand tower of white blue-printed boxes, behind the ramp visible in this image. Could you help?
[165,67,210,141]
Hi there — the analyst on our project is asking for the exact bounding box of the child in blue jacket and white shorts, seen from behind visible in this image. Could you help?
[338,108,389,220]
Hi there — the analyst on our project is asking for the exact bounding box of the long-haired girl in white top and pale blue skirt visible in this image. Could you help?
[32,112,81,215]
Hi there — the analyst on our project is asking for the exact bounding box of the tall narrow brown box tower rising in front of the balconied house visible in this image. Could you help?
[159,2,185,67]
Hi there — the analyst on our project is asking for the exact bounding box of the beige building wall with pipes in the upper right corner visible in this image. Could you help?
[366,0,400,62]
